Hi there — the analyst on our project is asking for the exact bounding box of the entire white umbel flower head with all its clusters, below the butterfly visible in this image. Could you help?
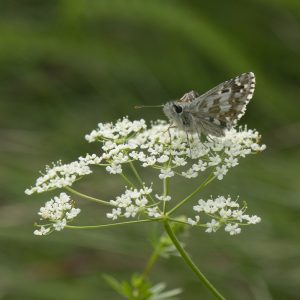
[25,117,266,235]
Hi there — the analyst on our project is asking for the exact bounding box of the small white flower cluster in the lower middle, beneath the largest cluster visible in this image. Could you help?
[106,187,160,220]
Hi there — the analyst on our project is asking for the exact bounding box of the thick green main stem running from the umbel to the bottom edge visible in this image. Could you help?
[164,220,225,300]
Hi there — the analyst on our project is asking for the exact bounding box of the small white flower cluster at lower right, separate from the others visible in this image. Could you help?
[187,196,261,235]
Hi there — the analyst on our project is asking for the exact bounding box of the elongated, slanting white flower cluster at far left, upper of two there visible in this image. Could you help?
[25,154,101,195]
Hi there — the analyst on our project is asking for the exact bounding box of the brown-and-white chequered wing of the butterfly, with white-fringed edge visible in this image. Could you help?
[190,72,255,130]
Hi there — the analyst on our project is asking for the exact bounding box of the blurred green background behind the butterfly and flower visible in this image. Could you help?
[0,0,300,300]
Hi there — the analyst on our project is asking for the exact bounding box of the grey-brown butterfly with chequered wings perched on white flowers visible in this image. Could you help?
[163,72,255,137]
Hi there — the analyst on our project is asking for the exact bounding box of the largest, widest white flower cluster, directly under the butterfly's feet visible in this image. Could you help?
[86,118,265,180]
